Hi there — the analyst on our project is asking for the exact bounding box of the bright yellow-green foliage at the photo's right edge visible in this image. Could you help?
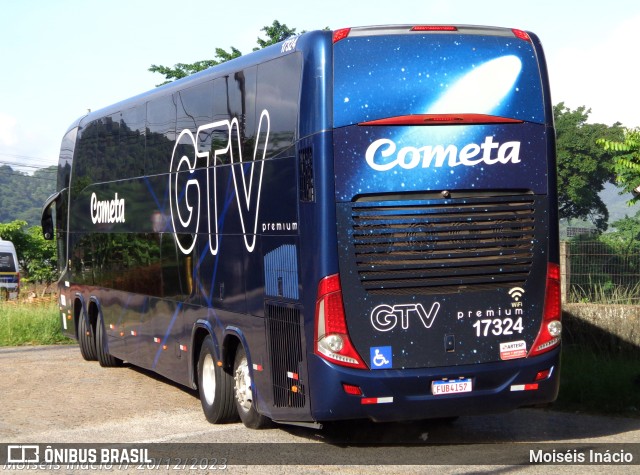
[598,128,640,205]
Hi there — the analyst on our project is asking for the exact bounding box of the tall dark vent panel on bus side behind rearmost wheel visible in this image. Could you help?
[265,304,306,407]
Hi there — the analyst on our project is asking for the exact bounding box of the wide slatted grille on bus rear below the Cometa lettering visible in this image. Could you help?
[351,195,535,295]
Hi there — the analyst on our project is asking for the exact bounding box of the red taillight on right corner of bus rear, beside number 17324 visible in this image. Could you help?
[529,263,562,356]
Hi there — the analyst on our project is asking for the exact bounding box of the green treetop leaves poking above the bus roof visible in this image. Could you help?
[149,20,304,86]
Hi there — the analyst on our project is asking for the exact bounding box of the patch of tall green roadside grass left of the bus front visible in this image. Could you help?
[0,300,73,346]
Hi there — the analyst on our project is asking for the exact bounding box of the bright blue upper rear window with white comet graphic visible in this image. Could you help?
[334,34,544,127]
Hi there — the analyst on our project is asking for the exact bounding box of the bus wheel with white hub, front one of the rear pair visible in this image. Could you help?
[198,335,238,424]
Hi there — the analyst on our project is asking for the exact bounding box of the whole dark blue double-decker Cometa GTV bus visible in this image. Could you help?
[42,25,562,428]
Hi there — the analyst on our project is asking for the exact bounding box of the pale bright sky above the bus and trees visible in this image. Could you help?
[0,0,640,177]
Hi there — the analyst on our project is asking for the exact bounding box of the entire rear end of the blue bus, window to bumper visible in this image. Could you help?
[310,26,561,420]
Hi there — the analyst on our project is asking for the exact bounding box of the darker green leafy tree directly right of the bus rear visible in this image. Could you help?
[553,102,623,231]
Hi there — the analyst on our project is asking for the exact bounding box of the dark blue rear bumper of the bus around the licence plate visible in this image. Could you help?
[309,348,560,421]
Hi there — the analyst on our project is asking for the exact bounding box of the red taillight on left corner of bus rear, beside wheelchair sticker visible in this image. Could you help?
[315,274,367,369]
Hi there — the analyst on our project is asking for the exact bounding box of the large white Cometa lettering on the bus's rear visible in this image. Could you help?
[365,136,520,172]
